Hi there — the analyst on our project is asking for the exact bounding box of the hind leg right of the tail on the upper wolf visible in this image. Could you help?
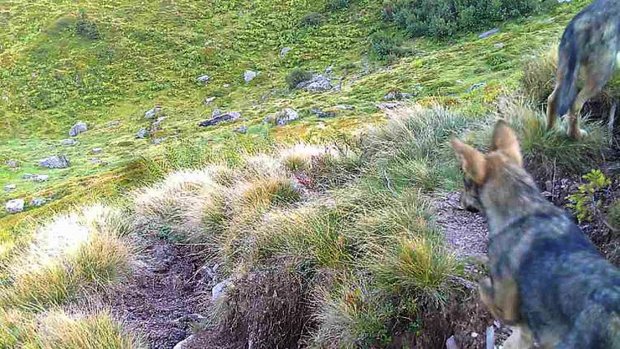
[568,55,616,139]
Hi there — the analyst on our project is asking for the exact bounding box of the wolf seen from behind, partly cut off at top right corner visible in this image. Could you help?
[547,0,620,139]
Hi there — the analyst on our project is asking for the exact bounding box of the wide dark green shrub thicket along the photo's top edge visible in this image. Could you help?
[383,0,542,38]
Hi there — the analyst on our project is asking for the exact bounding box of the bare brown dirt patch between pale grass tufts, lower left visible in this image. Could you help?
[109,240,211,349]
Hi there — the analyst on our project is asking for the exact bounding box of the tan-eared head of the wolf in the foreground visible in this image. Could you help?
[452,120,535,211]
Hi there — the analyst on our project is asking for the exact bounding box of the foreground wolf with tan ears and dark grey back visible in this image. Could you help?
[452,121,620,349]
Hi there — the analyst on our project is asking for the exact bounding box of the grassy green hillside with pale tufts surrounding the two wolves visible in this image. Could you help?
[0,0,620,348]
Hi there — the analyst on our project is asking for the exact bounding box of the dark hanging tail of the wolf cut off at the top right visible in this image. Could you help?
[555,26,581,116]
